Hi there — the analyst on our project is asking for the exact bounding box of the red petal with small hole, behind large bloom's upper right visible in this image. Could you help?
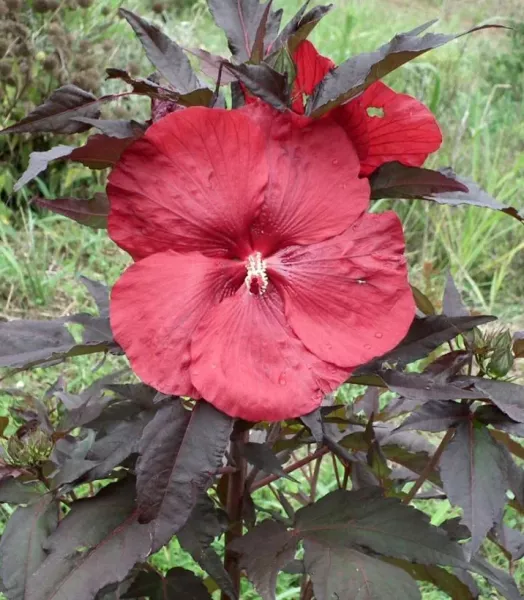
[340,81,442,176]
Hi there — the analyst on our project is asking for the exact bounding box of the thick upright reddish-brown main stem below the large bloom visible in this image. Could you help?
[221,421,249,600]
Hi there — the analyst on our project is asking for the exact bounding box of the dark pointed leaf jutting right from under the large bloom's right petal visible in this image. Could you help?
[355,315,496,374]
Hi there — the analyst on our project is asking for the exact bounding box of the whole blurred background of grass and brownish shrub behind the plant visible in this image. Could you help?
[0,0,524,600]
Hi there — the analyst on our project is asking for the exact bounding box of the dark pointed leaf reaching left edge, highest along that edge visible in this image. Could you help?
[0,84,100,133]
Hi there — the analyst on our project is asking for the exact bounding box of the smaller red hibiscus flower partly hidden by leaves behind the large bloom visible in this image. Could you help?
[293,40,442,176]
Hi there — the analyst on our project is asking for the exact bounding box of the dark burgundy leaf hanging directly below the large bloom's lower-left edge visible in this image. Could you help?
[137,398,233,546]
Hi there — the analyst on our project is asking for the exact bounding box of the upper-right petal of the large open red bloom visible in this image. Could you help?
[242,103,369,256]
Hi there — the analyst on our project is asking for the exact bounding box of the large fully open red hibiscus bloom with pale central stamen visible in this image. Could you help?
[108,104,415,421]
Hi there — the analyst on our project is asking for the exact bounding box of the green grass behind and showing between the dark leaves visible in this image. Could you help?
[0,0,524,600]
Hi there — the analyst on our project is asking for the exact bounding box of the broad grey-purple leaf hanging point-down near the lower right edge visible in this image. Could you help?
[440,421,509,556]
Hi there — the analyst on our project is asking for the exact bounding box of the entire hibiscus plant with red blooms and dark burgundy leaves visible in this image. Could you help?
[0,0,524,600]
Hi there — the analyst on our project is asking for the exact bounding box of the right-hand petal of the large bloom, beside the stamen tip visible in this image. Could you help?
[267,212,415,367]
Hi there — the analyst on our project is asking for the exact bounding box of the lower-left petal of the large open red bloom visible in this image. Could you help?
[110,252,245,397]
